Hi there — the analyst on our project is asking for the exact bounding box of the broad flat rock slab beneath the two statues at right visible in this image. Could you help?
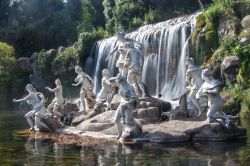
[142,120,246,143]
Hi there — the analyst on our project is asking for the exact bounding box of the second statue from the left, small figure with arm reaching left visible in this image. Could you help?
[45,79,64,118]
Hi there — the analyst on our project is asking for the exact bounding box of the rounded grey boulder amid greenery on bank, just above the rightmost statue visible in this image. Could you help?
[221,56,240,85]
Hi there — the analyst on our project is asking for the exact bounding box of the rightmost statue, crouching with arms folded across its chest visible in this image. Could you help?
[196,69,231,127]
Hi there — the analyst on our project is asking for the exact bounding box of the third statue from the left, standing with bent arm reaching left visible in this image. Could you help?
[72,66,95,111]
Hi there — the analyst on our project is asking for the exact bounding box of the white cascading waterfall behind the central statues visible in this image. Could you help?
[86,14,200,100]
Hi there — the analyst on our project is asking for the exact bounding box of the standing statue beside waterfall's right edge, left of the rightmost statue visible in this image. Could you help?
[186,58,204,117]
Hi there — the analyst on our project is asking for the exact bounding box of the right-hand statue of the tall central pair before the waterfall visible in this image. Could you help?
[124,42,146,97]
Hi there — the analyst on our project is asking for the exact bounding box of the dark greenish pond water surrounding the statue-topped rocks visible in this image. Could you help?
[0,111,250,166]
